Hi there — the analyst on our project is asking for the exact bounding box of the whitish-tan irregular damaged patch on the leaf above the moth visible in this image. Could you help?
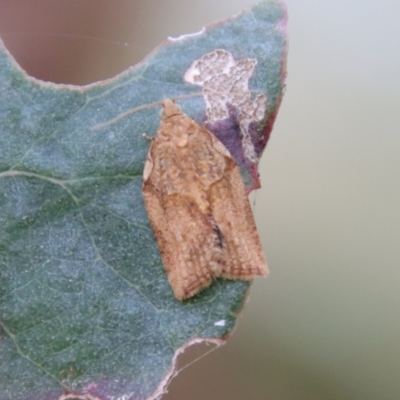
[184,49,267,162]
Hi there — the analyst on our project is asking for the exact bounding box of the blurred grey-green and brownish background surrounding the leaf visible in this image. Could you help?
[0,0,400,400]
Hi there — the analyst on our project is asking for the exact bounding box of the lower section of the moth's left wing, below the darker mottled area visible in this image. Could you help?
[143,179,227,300]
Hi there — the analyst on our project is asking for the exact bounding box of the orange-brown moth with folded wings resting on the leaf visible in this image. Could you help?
[143,99,268,300]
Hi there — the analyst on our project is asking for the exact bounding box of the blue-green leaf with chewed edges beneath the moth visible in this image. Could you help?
[0,1,286,400]
